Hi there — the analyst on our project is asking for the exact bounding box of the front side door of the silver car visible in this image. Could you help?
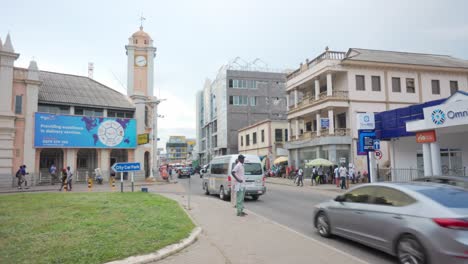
[329,186,373,241]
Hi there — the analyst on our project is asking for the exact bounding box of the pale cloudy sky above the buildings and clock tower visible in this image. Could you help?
[0,0,468,150]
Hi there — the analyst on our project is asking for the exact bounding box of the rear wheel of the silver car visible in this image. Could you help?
[397,235,427,264]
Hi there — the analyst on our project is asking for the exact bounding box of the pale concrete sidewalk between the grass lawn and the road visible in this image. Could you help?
[157,194,366,264]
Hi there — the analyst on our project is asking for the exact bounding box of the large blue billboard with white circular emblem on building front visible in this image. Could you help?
[34,113,137,148]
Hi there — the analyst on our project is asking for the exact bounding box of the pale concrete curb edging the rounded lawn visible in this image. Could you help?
[107,226,202,264]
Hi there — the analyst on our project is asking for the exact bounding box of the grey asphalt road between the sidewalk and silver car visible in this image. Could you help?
[179,175,396,264]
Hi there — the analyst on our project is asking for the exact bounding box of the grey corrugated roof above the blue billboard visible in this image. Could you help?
[39,71,135,109]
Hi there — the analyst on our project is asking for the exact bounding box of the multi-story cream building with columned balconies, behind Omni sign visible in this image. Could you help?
[286,48,468,170]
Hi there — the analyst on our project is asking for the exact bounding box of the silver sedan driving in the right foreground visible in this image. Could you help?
[314,182,468,264]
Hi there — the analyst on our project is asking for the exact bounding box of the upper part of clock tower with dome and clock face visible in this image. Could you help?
[125,26,156,97]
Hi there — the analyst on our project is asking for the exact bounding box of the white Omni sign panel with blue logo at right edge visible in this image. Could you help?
[424,100,468,128]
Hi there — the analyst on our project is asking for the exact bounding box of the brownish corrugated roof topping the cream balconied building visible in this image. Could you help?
[344,48,468,69]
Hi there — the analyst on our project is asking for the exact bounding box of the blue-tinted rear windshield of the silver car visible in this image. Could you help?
[416,187,468,209]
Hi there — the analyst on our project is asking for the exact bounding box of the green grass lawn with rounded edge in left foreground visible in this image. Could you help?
[0,192,194,263]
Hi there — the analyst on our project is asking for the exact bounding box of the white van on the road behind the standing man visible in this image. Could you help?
[202,155,266,200]
